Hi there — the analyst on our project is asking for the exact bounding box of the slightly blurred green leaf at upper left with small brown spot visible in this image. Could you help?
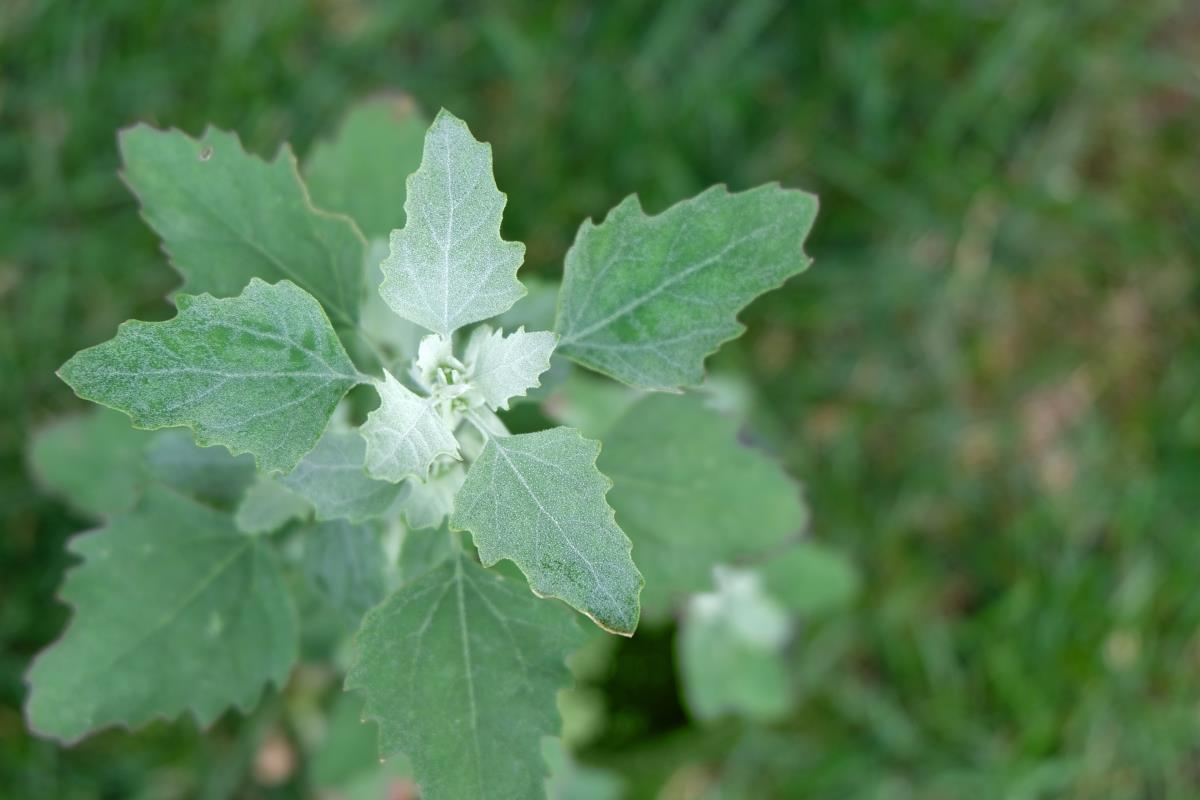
[120,125,366,329]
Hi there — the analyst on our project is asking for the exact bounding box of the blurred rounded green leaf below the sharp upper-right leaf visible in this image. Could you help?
[598,395,806,620]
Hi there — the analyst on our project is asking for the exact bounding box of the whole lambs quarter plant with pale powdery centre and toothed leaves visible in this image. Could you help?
[26,101,835,799]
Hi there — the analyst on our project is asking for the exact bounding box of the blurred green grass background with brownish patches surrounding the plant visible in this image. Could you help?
[0,0,1200,798]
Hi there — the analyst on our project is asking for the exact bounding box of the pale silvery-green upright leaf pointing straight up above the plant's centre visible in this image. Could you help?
[379,109,524,337]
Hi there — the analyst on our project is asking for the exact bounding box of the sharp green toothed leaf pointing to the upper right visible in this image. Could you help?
[556,184,817,391]
